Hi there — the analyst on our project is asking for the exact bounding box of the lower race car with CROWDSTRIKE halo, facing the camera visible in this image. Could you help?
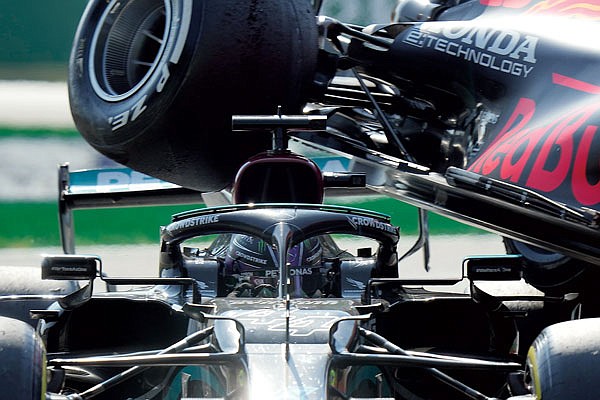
[0,116,596,399]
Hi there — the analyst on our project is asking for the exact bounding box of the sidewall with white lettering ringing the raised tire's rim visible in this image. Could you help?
[69,0,202,148]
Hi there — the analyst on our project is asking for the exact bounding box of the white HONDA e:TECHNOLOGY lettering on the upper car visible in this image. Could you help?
[403,23,539,78]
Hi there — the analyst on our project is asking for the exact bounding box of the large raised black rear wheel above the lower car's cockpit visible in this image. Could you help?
[69,0,317,191]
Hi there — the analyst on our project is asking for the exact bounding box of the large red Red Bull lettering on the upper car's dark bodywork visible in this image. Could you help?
[469,74,600,206]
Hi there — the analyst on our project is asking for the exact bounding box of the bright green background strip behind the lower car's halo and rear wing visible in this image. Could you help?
[0,198,483,248]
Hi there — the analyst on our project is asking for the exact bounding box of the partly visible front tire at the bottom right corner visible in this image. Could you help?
[527,318,600,400]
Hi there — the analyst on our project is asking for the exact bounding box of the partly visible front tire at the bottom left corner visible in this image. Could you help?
[0,317,46,400]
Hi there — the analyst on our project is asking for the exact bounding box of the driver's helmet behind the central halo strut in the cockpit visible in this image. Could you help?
[224,234,323,297]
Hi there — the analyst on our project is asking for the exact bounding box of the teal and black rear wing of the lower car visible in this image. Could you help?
[58,156,373,254]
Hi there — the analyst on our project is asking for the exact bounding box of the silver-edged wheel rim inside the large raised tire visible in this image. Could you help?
[89,0,171,101]
